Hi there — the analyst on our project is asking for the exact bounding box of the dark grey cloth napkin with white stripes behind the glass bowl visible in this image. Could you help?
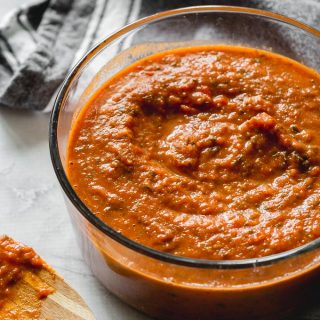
[0,0,320,110]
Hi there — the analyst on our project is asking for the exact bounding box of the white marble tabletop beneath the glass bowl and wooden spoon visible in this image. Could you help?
[0,0,147,320]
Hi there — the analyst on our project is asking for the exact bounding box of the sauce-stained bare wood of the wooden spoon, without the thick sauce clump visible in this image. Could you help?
[0,236,95,320]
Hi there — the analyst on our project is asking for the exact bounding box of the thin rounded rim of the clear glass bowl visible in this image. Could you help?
[49,5,320,269]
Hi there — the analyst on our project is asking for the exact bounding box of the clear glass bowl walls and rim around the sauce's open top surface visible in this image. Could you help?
[50,6,320,320]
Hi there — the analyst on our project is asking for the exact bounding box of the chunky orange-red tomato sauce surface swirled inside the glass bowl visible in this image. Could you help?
[67,46,320,260]
